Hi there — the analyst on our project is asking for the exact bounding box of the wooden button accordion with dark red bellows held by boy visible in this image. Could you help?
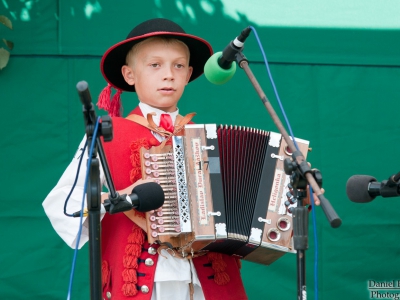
[141,124,309,265]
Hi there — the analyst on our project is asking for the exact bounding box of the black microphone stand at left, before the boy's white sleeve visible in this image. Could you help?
[74,81,132,300]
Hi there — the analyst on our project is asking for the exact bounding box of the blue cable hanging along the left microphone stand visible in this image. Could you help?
[67,117,100,300]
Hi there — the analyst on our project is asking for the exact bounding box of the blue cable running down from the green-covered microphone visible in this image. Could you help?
[250,26,318,300]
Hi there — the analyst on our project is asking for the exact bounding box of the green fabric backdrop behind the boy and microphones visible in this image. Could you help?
[0,0,400,300]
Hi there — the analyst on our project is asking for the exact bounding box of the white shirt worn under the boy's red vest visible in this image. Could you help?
[42,103,205,300]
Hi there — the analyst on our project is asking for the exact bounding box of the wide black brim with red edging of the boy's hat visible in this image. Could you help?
[100,31,213,92]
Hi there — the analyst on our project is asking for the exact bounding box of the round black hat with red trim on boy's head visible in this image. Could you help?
[100,19,213,92]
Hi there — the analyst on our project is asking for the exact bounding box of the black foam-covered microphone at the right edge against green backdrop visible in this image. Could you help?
[346,175,400,203]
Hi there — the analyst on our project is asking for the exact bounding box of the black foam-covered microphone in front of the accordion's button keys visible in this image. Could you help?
[73,182,165,217]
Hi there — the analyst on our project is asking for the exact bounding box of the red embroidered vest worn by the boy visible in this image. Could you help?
[101,107,247,300]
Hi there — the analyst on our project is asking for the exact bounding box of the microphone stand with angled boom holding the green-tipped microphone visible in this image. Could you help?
[231,49,342,300]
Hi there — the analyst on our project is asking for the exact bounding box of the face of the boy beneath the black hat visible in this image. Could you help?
[122,40,193,112]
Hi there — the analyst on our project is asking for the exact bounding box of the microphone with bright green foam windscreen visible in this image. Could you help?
[204,27,251,84]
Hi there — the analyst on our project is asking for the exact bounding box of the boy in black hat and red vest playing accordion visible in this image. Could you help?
[43,19,247,300]
